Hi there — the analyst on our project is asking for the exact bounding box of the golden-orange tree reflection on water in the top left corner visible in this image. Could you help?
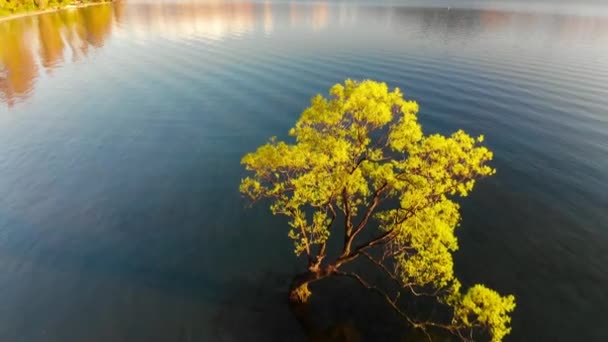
[0,2,124,106]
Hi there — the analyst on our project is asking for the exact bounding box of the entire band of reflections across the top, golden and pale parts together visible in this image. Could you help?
[0,0,608,105]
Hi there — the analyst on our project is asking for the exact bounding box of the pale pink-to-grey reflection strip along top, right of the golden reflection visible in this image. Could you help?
[124,0,608,44]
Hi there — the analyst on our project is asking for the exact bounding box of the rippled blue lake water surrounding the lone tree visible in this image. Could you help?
[0,1,608,341]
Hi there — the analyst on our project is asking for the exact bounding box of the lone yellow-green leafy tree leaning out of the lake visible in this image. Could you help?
[240,80,515,342]
